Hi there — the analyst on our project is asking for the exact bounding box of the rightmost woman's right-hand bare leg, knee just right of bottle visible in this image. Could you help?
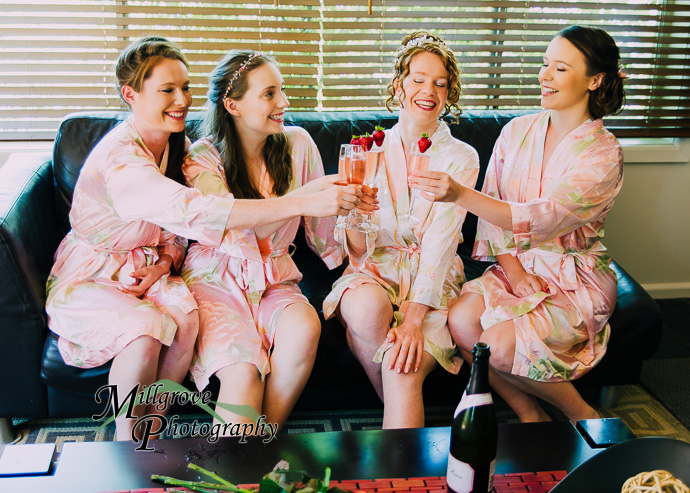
[481,322,599,423]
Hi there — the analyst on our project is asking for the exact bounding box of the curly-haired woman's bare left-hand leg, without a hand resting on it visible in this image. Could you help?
[339,284,393,401]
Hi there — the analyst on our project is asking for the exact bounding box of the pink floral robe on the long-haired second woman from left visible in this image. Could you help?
[182,127,344,390]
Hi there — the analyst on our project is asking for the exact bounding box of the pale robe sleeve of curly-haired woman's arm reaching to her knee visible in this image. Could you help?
[409,151,479,309]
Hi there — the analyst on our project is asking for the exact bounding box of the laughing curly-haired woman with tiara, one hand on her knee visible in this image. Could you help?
[323,31,479,428]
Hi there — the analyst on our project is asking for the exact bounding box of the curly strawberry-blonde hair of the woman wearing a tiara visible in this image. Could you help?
[386,31,462,123]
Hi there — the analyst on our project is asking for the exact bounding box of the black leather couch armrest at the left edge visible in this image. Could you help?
[0,153,60,417]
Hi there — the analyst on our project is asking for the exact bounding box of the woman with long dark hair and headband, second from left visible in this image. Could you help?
[182,51,366,434]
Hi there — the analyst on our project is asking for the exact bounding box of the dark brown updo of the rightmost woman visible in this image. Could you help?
[556,26,625,118]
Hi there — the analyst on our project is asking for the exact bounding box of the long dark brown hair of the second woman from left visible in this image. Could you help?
[203,50,292,199]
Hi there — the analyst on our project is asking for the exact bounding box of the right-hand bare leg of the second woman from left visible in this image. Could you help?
[263,303,321,429]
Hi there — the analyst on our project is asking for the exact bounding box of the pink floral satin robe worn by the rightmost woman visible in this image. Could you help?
[463,111,623,382]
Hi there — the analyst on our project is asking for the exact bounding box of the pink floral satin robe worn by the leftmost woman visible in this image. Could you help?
[46,119,234,368]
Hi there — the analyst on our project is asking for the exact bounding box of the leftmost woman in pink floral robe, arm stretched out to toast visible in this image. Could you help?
[46,37,356,440]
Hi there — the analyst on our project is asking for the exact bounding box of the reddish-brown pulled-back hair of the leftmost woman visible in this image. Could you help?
[115,36,189,185]
